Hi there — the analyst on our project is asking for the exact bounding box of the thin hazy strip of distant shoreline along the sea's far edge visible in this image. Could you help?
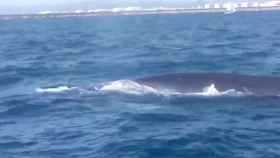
[0,6,280,20]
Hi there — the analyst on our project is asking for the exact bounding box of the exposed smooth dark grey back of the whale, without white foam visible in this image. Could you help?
[135,73,280,96]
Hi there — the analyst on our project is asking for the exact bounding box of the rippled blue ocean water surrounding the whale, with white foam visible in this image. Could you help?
[0,11,280,158]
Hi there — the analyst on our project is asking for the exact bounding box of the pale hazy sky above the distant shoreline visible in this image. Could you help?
[0,0,265,14]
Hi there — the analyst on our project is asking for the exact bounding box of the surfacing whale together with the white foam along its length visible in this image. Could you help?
[35,73,280,97]
